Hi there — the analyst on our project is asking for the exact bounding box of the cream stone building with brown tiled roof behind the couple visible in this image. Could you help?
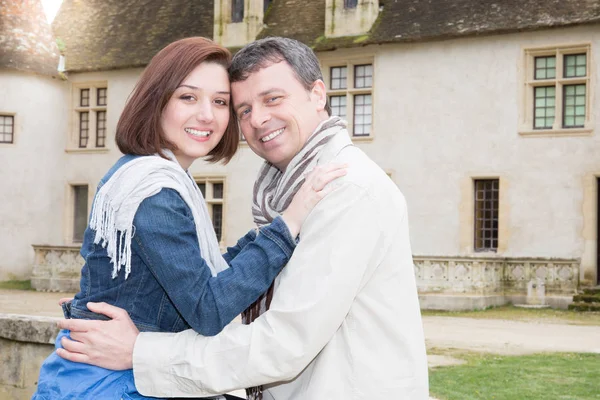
[0,0,600,309]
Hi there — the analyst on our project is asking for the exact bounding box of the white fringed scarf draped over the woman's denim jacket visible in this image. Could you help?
[90,150,228,279]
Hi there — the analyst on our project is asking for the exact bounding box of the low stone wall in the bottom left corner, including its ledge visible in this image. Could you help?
[0,314,58,400]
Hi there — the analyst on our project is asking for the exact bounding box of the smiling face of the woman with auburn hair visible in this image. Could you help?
[161,62,231,169]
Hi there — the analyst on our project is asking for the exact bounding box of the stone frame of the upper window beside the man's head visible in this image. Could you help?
[321,56,376,141]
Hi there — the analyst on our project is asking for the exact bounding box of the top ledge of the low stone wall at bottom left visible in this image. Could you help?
[0,313,60,344]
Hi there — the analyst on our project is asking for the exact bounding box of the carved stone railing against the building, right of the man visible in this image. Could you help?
[413,256,580,309]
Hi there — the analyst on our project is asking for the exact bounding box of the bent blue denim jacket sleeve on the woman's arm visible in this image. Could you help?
[131,189,295,336]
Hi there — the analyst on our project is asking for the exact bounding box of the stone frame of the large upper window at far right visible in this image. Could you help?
[519,43,594,136]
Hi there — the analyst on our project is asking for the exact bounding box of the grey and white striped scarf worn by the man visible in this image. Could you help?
[242,117,346,400]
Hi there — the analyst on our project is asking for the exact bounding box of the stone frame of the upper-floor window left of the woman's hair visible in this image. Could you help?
[66,81,109,153]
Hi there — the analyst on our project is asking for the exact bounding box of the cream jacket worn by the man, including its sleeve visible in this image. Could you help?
[133,135,428,400]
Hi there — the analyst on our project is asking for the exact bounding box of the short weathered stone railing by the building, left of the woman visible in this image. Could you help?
[31,245,83,292]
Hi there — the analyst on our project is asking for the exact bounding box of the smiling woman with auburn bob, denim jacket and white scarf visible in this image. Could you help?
[33,38,345,399]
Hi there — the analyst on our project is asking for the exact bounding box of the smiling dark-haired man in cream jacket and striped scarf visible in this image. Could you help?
[59,38,428,400]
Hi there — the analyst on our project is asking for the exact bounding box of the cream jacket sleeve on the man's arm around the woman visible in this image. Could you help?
[133,184,394,397]
